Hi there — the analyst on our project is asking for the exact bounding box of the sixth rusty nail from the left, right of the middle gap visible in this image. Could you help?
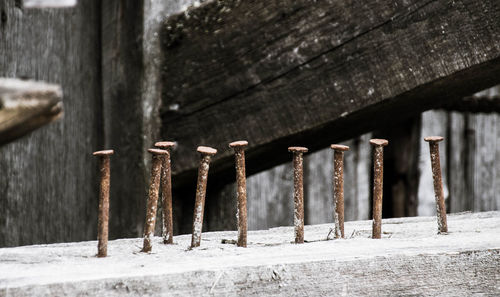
[288,146,307,243]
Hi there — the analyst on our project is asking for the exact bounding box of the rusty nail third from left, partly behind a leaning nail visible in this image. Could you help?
[155,141,175,244]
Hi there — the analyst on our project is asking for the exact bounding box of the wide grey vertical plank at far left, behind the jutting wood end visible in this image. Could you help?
[0,0,102,246]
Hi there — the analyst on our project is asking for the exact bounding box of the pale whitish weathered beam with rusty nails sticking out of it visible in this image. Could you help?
[0,212,500,296]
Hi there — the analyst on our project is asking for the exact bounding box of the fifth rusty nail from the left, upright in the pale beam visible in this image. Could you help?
[229,140,248,247]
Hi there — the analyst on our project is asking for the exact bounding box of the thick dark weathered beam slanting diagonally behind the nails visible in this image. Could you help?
[162,0,500,185]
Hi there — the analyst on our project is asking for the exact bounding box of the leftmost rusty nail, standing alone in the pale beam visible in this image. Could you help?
[93,150,114,257]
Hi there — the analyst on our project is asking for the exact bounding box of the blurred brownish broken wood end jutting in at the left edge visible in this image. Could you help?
[0,78,63,145]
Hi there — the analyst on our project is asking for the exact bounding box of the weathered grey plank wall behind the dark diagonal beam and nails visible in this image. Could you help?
[0,0,500,246]
